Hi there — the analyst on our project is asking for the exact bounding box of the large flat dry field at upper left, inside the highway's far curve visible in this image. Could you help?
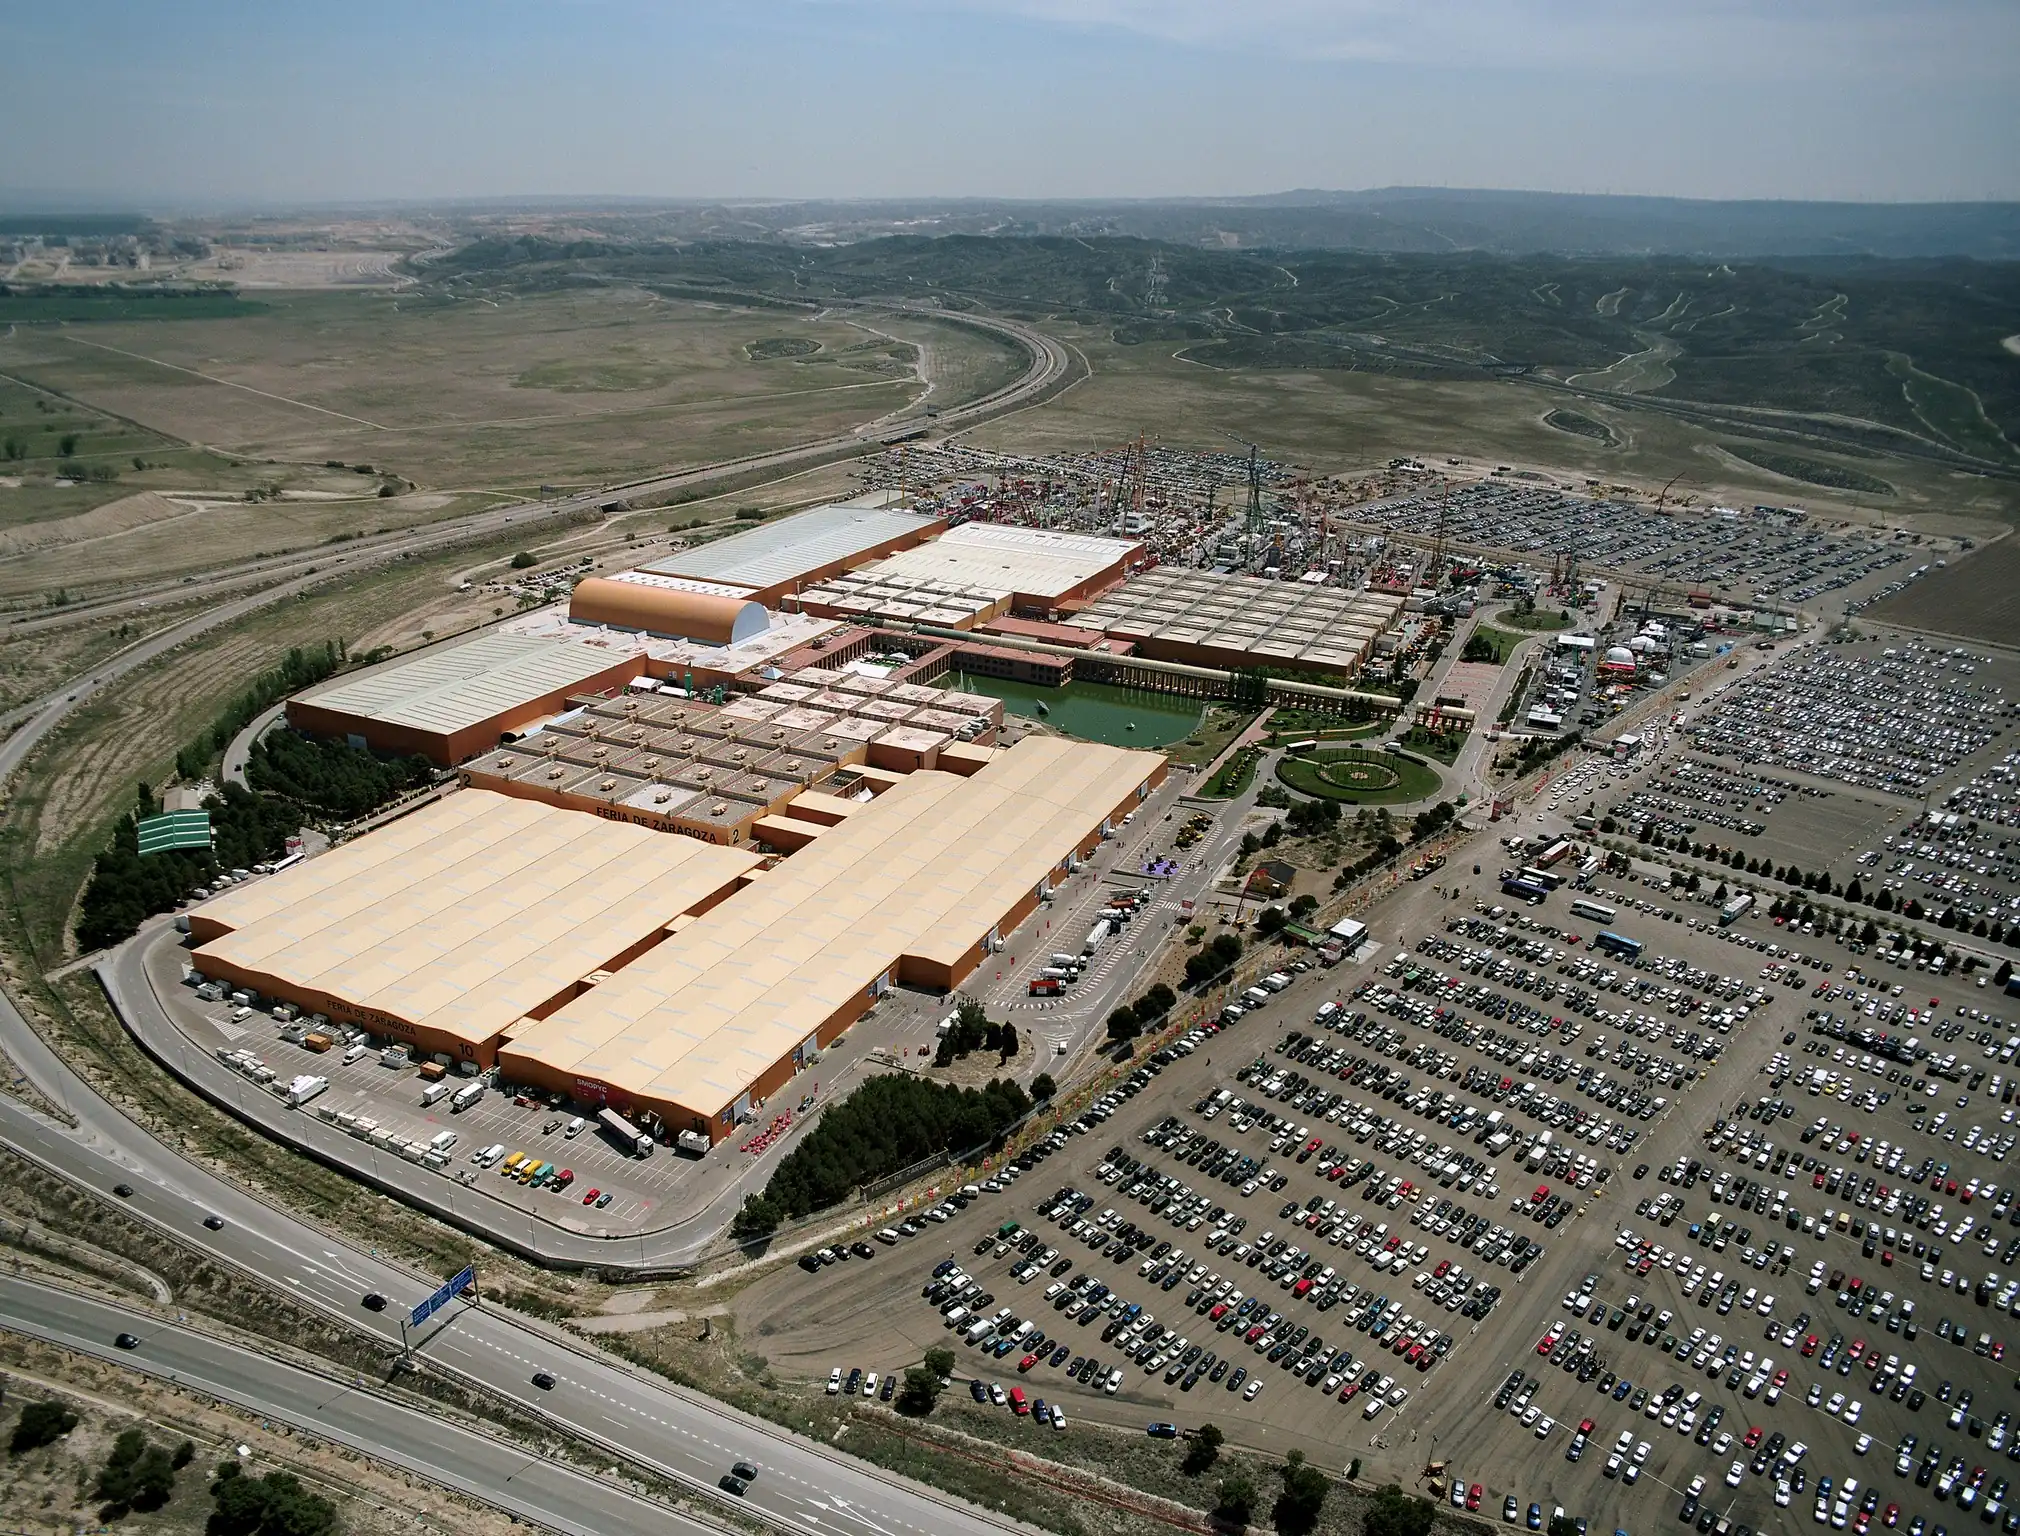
[0,291,945,487]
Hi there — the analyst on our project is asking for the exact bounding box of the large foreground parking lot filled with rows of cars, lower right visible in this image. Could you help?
[737,837,2020,1530]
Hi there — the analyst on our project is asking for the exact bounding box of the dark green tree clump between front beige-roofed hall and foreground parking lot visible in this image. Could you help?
[731,1075,1030,1237]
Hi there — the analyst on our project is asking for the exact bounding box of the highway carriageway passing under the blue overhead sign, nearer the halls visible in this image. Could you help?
[0,982,1028,1536]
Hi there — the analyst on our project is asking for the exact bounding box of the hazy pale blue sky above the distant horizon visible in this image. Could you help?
[0,0,2020,208]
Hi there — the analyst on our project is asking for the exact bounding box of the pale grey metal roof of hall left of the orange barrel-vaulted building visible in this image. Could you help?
[303,635,626,734]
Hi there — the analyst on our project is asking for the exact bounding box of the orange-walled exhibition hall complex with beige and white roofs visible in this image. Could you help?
[186,507,1260,1142]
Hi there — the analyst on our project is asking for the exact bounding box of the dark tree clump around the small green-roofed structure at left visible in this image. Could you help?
[77,784,299,950]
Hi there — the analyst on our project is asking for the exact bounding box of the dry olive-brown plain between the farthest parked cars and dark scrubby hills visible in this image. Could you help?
[953,317,2020,532]
